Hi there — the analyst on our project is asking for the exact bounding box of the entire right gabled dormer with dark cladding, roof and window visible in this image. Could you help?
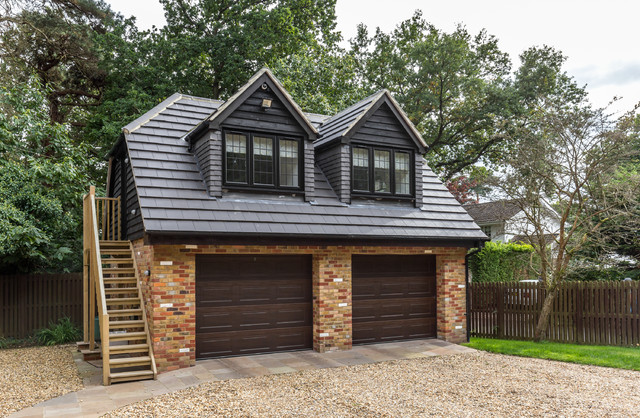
[314,90,426,206]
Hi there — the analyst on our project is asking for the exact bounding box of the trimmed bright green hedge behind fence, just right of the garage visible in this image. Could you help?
[469,242,536,283]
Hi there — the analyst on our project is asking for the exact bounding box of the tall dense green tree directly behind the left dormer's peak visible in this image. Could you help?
[152,0,337,99]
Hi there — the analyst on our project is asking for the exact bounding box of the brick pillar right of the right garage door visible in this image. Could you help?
[436,248,467,343]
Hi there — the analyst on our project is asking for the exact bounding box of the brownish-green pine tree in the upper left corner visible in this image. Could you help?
[0,0,111,126]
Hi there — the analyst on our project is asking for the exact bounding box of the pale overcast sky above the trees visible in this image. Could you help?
[107,0,640,111]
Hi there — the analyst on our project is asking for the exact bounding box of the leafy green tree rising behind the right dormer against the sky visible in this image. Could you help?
[351,11,515,180]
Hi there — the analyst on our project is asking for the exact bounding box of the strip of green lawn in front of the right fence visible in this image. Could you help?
[462,338,640,371]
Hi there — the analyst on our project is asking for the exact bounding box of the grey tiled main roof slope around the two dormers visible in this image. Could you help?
[124,94,486,241]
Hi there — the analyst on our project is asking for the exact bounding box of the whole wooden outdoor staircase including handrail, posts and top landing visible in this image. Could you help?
[82,186,158,385]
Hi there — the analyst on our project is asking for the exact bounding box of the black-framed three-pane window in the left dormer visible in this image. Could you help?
[224,131,302,190]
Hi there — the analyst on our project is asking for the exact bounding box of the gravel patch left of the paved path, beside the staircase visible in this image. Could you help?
[0,346,83,417]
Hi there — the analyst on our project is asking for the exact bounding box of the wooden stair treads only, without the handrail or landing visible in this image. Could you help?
[100,241,157,384]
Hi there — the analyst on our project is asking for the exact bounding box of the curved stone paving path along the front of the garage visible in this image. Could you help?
[11,339,475,417]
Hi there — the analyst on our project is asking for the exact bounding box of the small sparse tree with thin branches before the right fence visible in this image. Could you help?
[495,100,640,341]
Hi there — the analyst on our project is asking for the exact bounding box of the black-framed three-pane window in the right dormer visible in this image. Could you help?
[351,145,413,197]
